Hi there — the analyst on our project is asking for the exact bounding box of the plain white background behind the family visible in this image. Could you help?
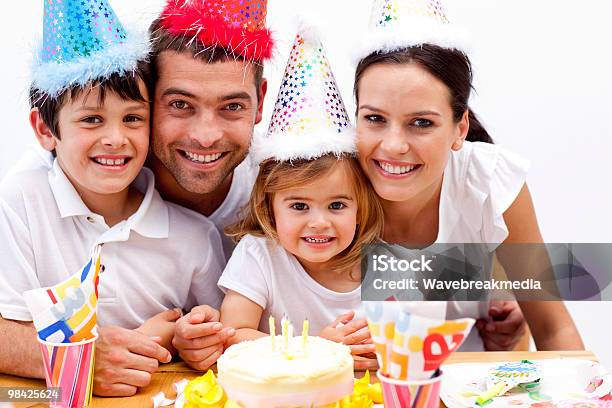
[0,0,612,368]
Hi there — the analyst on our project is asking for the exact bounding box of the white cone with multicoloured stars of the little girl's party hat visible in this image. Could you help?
[268,34,350,134]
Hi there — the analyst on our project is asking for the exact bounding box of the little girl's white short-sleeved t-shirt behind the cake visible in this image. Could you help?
[219,235,361,334]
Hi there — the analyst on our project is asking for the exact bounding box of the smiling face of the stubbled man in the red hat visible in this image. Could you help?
[151,51,266,194]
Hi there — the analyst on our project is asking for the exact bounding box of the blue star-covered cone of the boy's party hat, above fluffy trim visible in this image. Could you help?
[42,0,126,62]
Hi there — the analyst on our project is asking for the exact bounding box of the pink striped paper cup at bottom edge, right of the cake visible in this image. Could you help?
[376,370,442,408]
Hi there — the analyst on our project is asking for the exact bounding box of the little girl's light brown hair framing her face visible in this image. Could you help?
[226,155,383,276]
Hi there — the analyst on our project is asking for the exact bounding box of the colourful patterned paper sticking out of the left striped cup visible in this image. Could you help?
[23,245,101,343]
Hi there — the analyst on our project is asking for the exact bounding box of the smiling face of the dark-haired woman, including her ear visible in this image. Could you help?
[357,64,468,201]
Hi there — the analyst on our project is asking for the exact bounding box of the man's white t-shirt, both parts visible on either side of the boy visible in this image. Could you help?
[7,144,258,260]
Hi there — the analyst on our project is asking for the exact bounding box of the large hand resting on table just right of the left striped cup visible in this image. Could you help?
[94,326,172,397]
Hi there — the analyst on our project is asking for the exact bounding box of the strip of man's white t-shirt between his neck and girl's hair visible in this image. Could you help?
[208,157,258,260]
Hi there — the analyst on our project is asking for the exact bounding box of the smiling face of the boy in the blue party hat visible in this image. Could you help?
[54,81,149,198]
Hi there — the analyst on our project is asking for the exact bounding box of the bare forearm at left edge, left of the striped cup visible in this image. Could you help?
[0,317,45,378]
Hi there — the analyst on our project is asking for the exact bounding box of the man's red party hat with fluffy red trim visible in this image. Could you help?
[161,0,274,61]
